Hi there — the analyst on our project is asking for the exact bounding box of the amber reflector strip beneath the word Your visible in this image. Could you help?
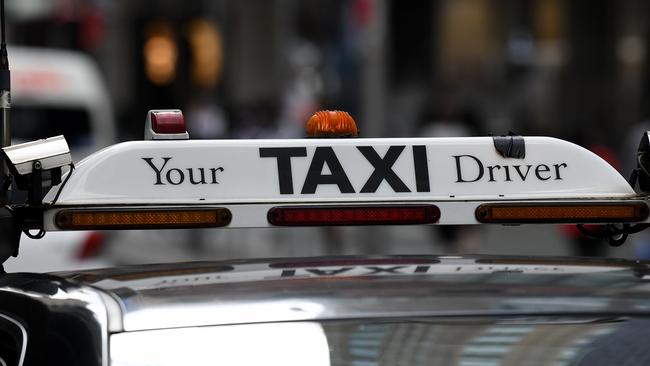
[56,208,232,230]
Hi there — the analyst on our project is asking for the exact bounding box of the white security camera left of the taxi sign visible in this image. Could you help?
[2,136,72,176]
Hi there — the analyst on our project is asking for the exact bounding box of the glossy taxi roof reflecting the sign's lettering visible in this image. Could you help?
[29,256,650,331]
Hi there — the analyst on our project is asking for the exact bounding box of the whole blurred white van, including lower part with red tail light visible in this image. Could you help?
[5,46,116,272]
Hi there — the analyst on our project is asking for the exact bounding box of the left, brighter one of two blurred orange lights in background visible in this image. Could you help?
[143,23,178,85]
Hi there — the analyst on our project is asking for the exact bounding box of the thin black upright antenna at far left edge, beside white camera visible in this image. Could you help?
[0,0,11,206]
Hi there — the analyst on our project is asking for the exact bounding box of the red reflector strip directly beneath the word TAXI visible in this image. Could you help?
[267,205,440,226]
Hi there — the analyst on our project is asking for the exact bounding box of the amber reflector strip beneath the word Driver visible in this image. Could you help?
[476,202,648,224]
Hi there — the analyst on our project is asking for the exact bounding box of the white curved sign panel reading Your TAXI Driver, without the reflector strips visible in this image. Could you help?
[45,137,635,206]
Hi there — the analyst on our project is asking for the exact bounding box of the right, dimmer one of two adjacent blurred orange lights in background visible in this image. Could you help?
[187,19,223,88]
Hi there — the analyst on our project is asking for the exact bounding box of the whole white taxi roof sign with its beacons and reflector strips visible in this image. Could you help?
[1,110,648,250]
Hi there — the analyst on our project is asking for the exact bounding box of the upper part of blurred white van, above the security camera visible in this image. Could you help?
[9,47,115,157]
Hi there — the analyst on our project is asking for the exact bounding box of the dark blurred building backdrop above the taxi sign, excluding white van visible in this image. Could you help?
[8,0,650,157]
